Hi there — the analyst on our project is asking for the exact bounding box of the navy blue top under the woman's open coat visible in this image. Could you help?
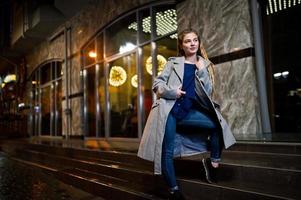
[171,63,196,119]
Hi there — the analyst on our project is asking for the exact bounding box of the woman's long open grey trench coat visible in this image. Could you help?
[138,57,236,174]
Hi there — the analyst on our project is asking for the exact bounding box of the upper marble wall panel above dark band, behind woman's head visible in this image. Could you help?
[177,0,253,57]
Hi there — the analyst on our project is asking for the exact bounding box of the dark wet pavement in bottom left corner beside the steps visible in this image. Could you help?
[0,152,104,200]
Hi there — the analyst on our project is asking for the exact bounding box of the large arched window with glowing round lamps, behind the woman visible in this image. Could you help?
[81,4,177,138]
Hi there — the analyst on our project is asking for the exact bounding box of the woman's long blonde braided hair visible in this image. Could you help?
[178,28,215,95]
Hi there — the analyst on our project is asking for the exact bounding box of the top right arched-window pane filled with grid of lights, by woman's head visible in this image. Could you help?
[154,5,178,38]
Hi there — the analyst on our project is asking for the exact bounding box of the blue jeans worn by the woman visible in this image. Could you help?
[161,109,222,188]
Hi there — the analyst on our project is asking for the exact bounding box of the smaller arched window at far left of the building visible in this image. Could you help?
[31,61,62,135]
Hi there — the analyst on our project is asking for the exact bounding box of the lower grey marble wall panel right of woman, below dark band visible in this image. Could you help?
[214,57,262,136]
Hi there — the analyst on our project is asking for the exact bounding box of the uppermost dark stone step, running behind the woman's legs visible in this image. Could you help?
[26,144,301,170]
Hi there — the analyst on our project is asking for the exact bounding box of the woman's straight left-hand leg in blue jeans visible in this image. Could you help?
[161,113,178,190]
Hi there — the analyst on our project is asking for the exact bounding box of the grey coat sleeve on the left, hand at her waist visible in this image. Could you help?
[152,59,177,99]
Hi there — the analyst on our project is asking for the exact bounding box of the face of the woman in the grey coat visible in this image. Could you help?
[182,32,199,56]
